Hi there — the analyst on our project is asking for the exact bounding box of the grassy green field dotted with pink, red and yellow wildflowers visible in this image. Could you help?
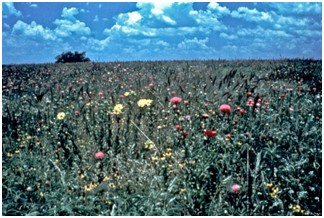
[2,59,322,216]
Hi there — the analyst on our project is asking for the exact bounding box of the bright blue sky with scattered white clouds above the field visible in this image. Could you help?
[2,2,322,64]
